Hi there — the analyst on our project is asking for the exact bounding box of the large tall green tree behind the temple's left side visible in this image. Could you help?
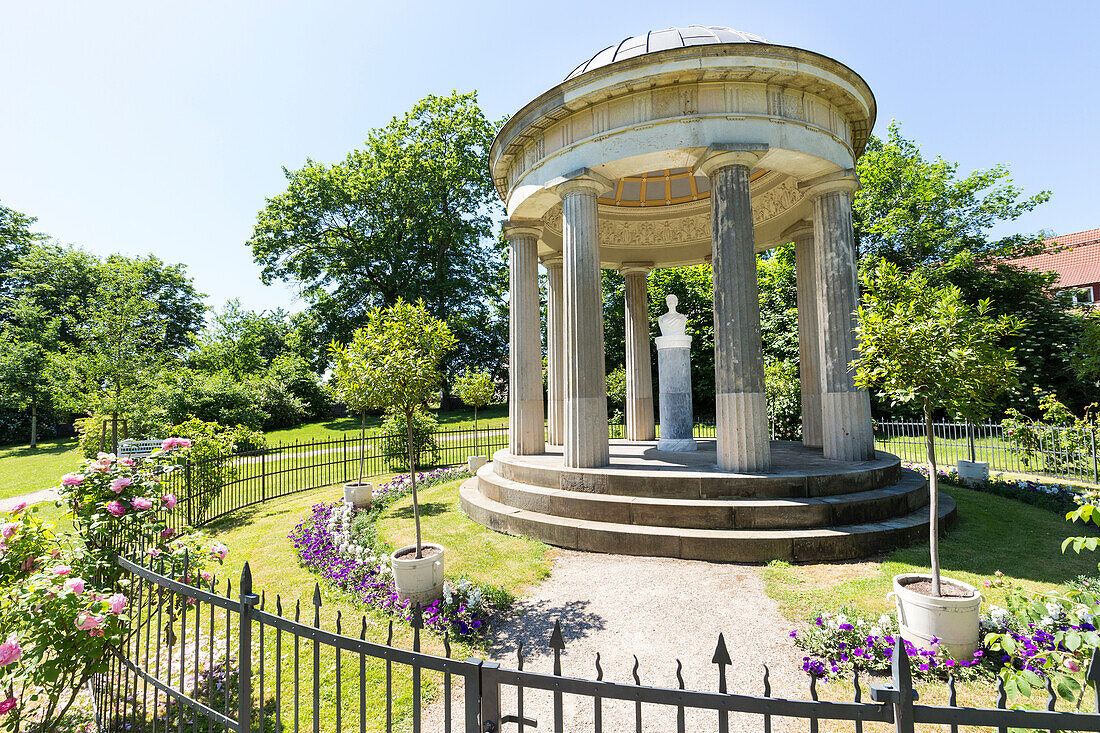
[249,92,506,367]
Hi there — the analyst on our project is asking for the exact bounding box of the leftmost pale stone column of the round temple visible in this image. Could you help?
[504,221,546,456]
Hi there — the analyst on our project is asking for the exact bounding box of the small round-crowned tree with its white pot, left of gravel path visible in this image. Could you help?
[348,298,455,604]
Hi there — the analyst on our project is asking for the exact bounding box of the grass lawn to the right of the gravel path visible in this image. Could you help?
[761,486,1100,717]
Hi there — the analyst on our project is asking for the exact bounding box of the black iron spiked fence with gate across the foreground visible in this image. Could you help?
[91,557,1100,733]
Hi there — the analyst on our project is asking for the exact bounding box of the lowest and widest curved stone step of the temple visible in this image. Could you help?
[459,477,956,562]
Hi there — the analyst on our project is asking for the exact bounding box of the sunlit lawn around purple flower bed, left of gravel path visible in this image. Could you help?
[198,473,551,731]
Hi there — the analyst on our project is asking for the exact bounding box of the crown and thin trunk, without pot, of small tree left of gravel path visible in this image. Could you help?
[332,298,455,559]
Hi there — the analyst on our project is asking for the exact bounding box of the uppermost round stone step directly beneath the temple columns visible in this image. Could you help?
[493,440,902,499]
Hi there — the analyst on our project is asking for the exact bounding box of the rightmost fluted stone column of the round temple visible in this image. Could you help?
[801,171,875,461]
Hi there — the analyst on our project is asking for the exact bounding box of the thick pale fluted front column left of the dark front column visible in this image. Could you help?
[557,176,609,468]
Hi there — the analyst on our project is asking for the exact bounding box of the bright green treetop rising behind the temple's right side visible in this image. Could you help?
[853,121,1051,271]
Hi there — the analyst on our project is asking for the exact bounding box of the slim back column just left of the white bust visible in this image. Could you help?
[619,262,657,440]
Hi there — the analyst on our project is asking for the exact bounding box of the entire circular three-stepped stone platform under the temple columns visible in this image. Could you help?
[460,439,955,562]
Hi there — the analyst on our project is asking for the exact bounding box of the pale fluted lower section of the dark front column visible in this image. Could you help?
[715,392,771,473]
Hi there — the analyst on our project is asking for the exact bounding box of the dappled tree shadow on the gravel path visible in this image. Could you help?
[488,599,607,663]
